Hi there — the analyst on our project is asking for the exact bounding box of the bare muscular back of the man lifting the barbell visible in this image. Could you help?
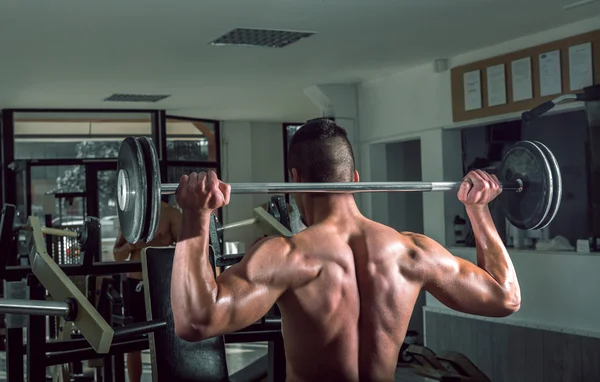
[278,219,422,381]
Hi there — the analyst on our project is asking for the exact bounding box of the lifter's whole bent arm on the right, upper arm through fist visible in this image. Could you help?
[409,174,521,317]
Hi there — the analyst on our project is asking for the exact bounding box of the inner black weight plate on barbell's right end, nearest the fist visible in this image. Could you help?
[498,141,553,230]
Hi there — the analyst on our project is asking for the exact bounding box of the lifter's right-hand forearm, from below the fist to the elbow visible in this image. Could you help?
[467,206,518,290]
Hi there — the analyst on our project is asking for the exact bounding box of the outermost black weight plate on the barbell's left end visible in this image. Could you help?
[117,137,147,244]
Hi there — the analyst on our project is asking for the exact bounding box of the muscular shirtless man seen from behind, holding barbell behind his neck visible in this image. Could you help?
[171,119,520,382]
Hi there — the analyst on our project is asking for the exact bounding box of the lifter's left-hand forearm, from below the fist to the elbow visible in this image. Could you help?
[171,212,217,333]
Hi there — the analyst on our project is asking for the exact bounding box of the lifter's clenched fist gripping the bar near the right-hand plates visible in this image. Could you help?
[458,170,502,206]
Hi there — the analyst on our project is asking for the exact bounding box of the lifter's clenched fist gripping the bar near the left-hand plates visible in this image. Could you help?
[177,171,231,212]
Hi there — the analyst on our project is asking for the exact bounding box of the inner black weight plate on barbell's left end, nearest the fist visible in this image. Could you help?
[137,137,161,243]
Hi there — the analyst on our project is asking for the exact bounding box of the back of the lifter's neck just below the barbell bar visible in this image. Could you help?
[306,194,362,225]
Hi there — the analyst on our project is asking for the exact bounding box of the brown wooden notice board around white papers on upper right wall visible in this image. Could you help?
[450,30,600,122]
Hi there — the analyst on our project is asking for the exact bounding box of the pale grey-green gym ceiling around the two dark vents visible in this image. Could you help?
[0,0,600,122]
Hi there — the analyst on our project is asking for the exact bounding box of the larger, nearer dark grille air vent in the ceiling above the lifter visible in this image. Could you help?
[211,28,315,48]
